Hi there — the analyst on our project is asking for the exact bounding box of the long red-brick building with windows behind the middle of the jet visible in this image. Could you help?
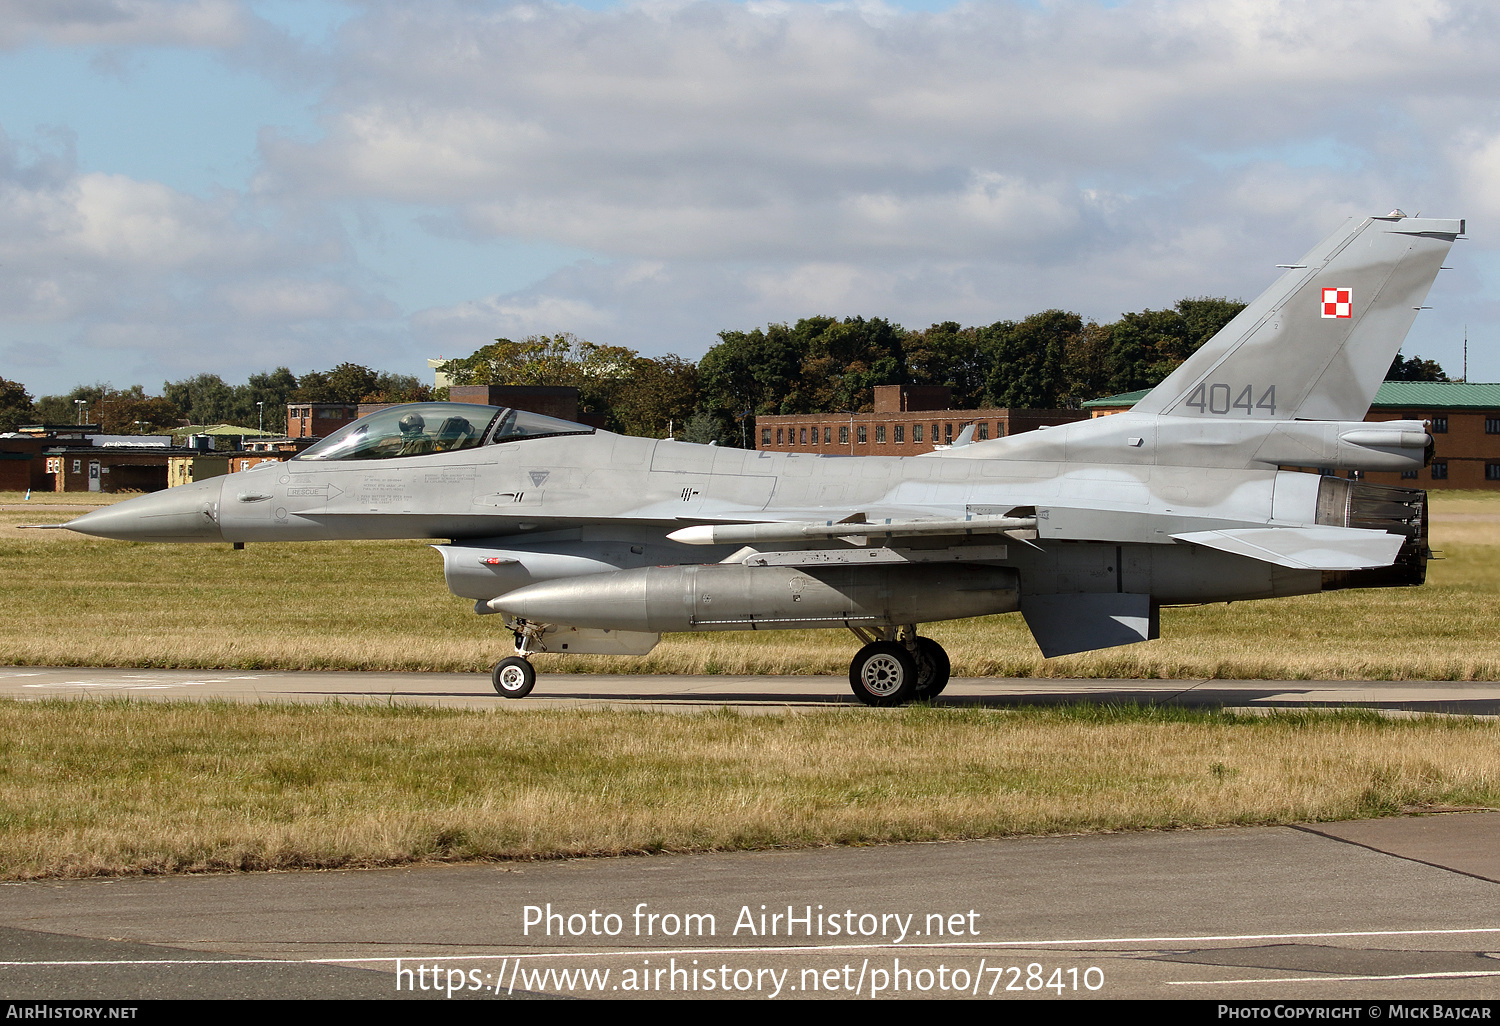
[755,386,1088,456]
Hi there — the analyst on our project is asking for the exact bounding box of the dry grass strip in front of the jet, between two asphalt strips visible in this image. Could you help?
[0,702,1500,879]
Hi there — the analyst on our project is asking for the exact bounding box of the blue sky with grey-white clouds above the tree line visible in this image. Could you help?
[0,0,1500,395]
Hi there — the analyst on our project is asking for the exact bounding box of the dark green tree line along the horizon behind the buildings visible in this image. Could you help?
[0,297,1448,446]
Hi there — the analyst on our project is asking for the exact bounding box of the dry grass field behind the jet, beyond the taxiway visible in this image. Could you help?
[0,492,1500,680]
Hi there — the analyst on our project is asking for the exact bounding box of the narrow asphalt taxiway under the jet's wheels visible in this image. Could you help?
[0,666,1500,716]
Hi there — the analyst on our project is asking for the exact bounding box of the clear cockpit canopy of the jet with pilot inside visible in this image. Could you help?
[297,402,594,459]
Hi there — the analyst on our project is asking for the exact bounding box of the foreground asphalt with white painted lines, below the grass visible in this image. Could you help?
[0,813,1500,1002]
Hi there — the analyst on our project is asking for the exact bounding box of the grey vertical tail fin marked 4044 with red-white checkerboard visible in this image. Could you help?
[1134,212,1464,420]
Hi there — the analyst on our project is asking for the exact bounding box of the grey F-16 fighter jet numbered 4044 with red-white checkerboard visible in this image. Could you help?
[49,210,1464,705]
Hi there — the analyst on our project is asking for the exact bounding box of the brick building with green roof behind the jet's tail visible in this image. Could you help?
[1083,381,1500,489]
